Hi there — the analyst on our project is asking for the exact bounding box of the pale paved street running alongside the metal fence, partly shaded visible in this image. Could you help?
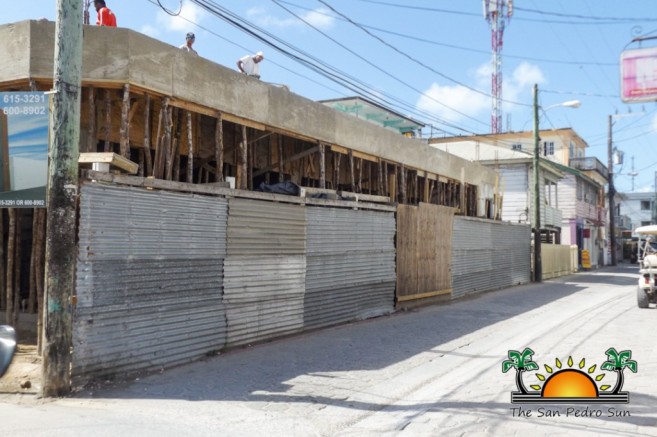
[0,265,657,437]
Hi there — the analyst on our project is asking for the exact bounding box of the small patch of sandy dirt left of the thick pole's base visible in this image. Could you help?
[0,344,41,395]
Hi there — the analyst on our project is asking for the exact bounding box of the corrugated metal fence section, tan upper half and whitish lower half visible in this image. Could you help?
[224,199,306,346]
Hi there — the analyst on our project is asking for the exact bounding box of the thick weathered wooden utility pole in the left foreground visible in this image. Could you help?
[42,0,82,397]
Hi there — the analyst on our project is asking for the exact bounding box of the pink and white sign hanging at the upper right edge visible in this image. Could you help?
[620,47,657,103]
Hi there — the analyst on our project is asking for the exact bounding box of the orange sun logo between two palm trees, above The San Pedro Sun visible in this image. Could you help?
[502,347,637,404]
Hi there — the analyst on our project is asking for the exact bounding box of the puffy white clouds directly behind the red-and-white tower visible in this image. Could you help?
[417,62,545,122]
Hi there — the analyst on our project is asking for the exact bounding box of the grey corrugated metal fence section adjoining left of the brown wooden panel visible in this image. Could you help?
[304,207,396,328]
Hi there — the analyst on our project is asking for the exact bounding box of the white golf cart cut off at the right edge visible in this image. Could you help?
[634,225,657,308]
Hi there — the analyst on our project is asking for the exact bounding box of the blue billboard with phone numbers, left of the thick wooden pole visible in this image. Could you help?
[0,91,50,208]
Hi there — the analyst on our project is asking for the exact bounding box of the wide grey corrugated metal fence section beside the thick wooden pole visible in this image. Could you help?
[72,184,227,382]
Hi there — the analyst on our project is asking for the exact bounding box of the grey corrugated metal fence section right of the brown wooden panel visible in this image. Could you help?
[452,217,531,297]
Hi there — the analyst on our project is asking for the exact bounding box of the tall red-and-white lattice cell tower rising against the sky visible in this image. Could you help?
[484,0,513,134]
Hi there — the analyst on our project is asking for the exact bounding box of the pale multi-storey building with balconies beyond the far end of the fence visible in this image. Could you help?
[429,128,611,267]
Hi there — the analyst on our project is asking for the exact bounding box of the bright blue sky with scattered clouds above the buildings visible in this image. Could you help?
[2,0,657,191]
